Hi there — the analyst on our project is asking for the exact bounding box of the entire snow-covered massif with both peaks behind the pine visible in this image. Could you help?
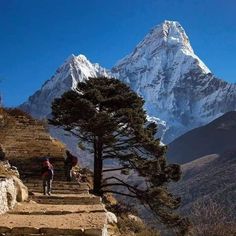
[20,21,236,143]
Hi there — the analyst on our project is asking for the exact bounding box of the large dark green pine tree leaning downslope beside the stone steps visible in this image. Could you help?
[50,77,192,235]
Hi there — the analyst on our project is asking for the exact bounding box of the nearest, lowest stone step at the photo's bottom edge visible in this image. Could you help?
[0,212,106,236]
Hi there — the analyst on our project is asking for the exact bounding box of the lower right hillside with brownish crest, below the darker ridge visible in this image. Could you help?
[173,149,236,213]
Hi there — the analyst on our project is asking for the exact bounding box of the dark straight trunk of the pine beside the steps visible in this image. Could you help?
[93,137,103,195]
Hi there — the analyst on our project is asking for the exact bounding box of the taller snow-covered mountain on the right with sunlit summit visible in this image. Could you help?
[112,21,236,143]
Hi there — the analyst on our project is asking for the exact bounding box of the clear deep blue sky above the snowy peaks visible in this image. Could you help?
[0,0,236,106]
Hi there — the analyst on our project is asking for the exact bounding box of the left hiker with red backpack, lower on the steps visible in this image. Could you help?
[42,158,54,196]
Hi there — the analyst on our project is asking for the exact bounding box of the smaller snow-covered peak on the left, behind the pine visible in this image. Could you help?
[20,55,108,119]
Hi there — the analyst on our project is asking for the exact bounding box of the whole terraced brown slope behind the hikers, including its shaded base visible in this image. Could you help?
[0,108,65,178]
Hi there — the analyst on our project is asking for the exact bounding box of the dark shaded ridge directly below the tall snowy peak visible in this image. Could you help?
[167,111,236,164]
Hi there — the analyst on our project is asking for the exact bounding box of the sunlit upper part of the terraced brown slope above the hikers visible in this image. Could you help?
[0,110,65,160]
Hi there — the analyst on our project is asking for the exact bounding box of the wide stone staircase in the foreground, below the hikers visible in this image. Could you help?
[0,180,108,236]
